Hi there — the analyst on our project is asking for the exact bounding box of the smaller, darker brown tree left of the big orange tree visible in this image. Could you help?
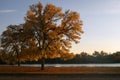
[1,25,23,66]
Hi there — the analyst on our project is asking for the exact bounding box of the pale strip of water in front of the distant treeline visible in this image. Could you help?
[21,63,120,67]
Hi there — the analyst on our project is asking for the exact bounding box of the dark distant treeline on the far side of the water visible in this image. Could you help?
[0,51,120,64]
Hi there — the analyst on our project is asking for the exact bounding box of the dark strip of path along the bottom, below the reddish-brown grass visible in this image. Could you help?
[0,74,120,80]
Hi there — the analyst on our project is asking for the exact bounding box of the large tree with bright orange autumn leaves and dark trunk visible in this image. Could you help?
[24,3,83,70]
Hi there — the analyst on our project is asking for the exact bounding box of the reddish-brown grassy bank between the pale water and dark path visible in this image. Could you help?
[0,66,120,74]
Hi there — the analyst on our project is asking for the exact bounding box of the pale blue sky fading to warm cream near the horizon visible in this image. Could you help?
[0,0,120,54]
